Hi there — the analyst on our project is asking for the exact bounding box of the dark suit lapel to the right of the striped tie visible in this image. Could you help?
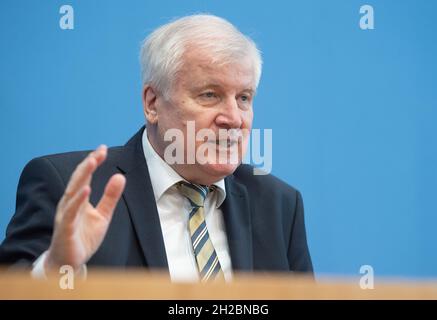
[222,176,253,271]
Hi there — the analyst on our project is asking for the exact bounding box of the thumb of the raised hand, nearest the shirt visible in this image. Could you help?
[96,174,126,220]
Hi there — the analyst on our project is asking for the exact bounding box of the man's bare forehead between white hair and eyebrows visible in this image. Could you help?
[178,49,255,91]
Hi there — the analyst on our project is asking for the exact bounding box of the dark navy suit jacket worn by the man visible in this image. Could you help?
[0,127,312,272]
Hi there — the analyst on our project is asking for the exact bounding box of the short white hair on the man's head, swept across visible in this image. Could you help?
[140,14,262,98]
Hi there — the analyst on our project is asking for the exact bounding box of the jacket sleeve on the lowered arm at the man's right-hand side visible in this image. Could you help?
[288,191,313,273]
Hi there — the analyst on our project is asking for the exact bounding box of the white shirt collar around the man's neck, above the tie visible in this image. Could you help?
[142,130,226,208]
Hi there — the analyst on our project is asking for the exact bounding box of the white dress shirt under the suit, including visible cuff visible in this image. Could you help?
[31,130,232,281]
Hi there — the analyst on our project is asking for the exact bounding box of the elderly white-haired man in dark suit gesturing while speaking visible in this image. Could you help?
[0,15,312,281]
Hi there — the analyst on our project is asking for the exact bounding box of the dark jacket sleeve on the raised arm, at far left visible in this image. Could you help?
[0,158,65,268]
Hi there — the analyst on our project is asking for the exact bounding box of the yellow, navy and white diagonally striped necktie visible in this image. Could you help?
[177,181,224,281]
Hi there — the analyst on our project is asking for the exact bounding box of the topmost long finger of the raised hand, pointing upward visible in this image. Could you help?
[64,145,107,200]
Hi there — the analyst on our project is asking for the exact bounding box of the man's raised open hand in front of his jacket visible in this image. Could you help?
[44,146,126,270]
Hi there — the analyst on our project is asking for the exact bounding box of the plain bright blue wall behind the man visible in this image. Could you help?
[0,0,437,277]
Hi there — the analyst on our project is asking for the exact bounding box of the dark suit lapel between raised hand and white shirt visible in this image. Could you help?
[118,127,168,269]
